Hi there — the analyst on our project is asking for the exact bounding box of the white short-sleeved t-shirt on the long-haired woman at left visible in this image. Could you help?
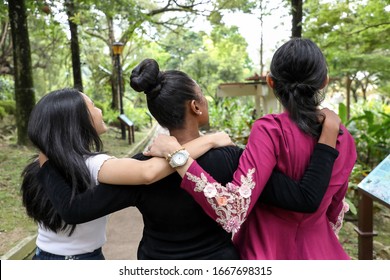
[36,154,112,256]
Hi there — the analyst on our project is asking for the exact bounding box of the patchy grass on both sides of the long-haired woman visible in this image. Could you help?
[0,117,148,256]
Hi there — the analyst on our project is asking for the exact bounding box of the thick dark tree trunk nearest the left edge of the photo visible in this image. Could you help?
[8,0,35,145]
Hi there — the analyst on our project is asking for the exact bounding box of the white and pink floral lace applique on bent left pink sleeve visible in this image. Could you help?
[186,168,256,234]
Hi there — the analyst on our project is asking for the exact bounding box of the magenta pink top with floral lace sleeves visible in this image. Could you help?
[182,113,356,259]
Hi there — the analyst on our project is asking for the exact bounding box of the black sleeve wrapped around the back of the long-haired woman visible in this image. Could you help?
[38,161,144,224]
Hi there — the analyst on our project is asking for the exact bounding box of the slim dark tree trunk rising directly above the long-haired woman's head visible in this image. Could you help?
[65,0,83,91]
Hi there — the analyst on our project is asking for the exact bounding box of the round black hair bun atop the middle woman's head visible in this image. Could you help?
[130,58,162,98]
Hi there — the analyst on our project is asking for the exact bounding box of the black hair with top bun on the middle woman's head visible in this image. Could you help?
[130,59,199,130]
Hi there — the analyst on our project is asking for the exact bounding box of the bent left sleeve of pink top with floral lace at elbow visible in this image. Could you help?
[181,117,280,233]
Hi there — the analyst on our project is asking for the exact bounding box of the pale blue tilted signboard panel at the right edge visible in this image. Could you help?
[358,155,390,207]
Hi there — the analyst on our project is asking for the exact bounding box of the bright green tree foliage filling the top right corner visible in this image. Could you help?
[303,0,390,98]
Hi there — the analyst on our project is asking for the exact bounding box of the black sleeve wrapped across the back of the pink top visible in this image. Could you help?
[259,143,339,213]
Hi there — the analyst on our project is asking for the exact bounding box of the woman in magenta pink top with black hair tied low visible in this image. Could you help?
[146,38,356,260]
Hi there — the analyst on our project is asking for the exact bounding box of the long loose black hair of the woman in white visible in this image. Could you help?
[21,88,103,234]
